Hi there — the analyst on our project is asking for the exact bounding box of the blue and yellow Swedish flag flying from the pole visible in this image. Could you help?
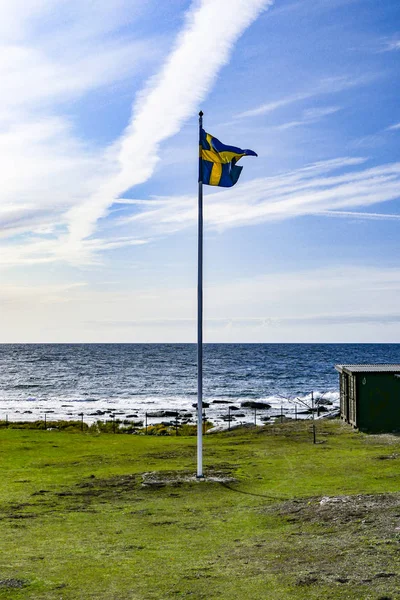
[199,128,257,187]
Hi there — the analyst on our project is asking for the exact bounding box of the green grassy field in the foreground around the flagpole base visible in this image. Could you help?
[0,421,400,600]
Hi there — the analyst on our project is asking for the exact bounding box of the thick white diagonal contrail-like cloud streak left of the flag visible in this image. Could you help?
[66,0,273,253]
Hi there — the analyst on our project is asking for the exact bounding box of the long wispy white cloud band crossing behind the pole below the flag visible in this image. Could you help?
[120,158,400,235]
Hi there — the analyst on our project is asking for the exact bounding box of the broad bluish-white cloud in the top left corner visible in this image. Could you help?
[0,0,161,123]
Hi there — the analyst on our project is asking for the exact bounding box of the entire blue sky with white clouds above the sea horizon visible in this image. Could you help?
[0,0,400,342]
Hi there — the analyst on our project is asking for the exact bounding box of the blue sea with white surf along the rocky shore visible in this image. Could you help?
[0,344,400,426]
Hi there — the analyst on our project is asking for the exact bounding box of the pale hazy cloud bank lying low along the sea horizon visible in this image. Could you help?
[0,264,400,342]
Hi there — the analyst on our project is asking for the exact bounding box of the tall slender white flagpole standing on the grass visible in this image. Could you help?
[197,111,204,478]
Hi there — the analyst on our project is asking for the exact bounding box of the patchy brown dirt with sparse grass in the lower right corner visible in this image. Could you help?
[239,493,400,599]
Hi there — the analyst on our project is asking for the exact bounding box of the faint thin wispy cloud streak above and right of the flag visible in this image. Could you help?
[236,75,375,119]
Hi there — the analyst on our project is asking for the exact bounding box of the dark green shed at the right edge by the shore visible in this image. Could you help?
[335,364,400,433]
